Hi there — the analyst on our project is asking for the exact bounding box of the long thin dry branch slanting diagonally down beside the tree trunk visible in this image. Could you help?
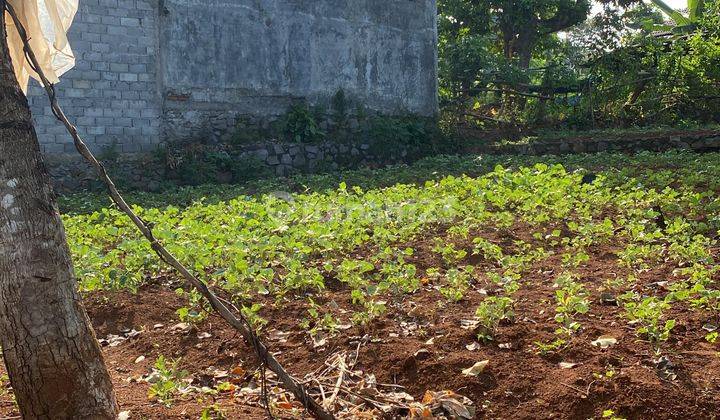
[6,3,335,420]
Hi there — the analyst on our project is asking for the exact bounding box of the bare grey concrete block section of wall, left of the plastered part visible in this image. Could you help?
[28,0,161,155]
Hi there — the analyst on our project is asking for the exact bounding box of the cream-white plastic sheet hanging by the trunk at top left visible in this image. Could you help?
[5,0,78,90]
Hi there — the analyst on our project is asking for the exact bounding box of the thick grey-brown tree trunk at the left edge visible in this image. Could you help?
[0,4,118,419]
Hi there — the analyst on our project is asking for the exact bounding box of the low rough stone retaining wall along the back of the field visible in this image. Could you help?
[47,131,720,192]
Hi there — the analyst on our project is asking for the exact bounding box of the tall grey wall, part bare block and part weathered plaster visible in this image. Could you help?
[29,0,438,156]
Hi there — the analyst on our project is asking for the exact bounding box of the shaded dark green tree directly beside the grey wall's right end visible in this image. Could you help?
[439,0,590,122]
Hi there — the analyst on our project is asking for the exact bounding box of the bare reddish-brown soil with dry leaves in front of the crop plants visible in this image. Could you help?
[0,229,720,419]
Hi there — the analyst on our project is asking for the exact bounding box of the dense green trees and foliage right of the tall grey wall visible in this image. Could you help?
[439,0,720,130]
